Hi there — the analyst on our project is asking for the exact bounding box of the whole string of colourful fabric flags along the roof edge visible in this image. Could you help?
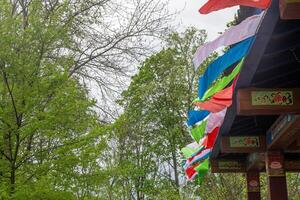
[181,0,262,183]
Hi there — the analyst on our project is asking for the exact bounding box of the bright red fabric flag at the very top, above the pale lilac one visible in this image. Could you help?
[199,0,271,14]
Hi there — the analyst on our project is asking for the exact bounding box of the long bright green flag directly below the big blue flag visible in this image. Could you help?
[200,58,244,101]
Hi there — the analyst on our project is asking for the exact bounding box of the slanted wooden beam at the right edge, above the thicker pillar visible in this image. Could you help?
[267,115,300,150]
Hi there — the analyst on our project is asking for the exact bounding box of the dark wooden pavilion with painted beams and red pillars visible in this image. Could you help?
[210,0,300,200]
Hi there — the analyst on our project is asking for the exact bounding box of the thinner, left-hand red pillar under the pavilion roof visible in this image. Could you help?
[246,170,260,200]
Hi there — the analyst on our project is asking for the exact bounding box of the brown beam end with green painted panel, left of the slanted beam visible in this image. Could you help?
[221,136,266,153]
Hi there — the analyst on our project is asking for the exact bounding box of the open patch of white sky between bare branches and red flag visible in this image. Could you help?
[170,0,238,40]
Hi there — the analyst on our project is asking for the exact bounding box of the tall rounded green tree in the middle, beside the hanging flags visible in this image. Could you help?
[101,28,206,199]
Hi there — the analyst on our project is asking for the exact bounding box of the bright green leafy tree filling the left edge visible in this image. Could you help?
[0,1,106,200]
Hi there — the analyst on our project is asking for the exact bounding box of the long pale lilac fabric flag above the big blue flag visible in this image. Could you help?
[193,12,264,68]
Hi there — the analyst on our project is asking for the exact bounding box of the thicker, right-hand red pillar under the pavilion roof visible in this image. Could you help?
[266,151,288,200]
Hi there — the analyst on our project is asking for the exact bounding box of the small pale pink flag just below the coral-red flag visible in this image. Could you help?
[205,108,227,134]
